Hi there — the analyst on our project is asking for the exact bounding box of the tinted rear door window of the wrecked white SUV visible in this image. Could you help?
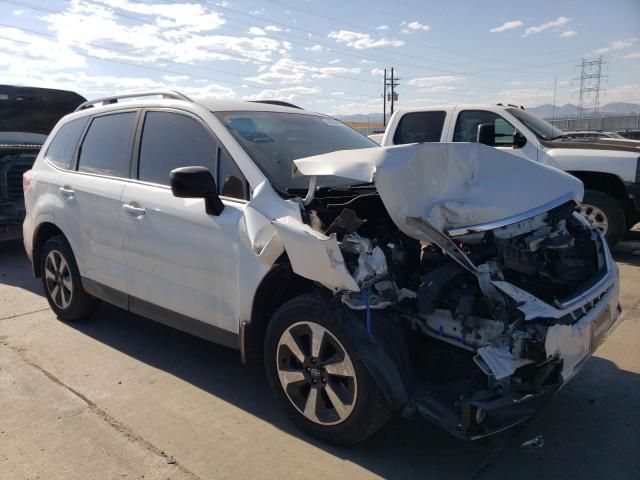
[78,112,136,177]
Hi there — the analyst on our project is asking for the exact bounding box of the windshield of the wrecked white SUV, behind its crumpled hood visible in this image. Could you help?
[214,112,378,192]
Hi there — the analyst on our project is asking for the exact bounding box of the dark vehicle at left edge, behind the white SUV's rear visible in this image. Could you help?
[0,85,85,241]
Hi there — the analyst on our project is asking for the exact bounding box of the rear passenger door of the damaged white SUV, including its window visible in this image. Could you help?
[55,110,138,291]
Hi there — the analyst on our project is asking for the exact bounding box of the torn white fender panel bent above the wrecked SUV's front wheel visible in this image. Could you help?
[273,217,360,291]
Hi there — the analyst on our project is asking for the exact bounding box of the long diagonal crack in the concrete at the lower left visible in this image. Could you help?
[0,340,201,480]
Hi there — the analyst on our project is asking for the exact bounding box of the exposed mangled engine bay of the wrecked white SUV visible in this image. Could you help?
[303,186,606,437]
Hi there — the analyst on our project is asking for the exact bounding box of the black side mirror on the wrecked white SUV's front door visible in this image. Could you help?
[169,167,224,215]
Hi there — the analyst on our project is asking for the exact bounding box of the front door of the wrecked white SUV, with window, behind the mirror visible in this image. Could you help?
[120,109,248,333]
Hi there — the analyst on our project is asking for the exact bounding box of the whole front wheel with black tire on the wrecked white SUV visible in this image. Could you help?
[264,294,392,445]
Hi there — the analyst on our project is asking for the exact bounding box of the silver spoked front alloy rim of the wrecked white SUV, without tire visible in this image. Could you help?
[276,321,358,425]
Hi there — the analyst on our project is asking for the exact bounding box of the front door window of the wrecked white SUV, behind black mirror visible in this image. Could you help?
[138,112,218,185]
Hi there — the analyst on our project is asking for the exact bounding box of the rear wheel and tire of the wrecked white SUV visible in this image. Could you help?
[40,235,100,322]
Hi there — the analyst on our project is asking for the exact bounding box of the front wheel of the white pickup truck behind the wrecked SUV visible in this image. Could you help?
[580,190,627,247]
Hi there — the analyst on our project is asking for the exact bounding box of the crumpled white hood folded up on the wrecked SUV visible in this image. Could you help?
[294,143,584,239]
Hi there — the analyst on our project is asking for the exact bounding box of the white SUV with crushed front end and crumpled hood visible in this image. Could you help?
[24,92,620,444]
